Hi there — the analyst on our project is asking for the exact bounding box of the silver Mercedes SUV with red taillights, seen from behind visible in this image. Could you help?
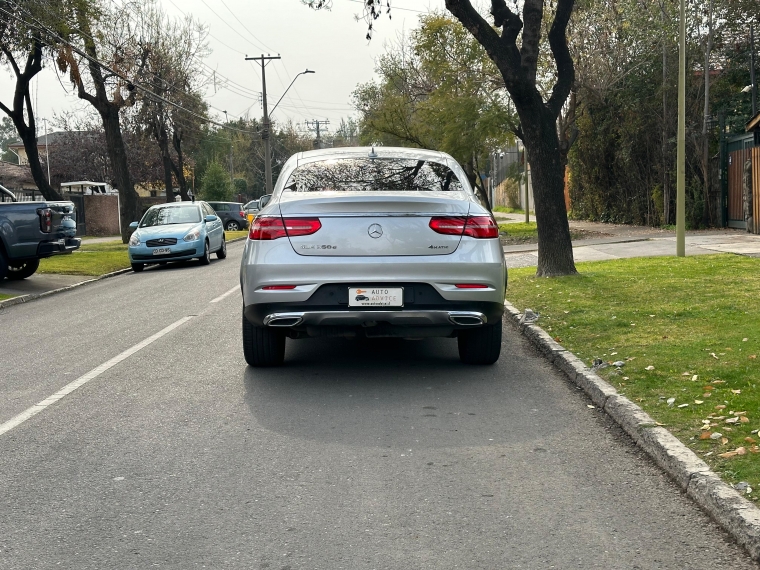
[240,147,507,366]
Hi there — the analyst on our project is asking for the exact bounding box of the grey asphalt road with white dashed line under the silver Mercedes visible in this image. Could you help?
[0,244,757,570]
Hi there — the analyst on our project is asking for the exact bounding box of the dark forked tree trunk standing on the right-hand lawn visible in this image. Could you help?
[301,0,576,277]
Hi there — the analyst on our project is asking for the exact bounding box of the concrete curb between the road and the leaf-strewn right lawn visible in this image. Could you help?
[504,301,760,562]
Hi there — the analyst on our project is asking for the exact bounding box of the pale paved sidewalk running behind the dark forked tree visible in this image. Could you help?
[494,212,760,268]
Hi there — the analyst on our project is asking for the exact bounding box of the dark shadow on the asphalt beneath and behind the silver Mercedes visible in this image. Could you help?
[243,332,569,447]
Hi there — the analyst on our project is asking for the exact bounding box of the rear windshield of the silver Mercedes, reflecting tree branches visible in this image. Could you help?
[284,158,462,192]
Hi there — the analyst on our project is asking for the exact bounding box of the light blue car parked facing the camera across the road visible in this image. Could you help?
[128,201,227,271]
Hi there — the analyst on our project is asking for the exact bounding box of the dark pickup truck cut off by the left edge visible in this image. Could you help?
[0,186,82,280]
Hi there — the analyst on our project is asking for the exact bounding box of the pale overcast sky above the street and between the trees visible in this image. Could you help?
[0,0,452,133]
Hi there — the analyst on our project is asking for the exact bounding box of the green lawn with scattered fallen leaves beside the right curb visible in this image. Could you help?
[507,254,760,500]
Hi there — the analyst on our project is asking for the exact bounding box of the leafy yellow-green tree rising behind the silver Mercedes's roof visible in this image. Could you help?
[354,13,516,209]
